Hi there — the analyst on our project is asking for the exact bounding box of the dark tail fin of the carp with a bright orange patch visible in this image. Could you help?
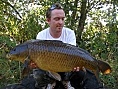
[97,60,111,74]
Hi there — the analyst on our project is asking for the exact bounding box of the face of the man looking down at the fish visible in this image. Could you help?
[47,9,65,33]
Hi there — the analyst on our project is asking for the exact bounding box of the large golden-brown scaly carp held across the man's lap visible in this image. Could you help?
[7,40,111,80]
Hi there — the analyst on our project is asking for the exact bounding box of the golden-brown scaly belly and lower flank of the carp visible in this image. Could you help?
[32,52,94,72]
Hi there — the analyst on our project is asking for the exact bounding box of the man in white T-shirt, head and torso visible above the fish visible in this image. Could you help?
[36,4,79,88]
